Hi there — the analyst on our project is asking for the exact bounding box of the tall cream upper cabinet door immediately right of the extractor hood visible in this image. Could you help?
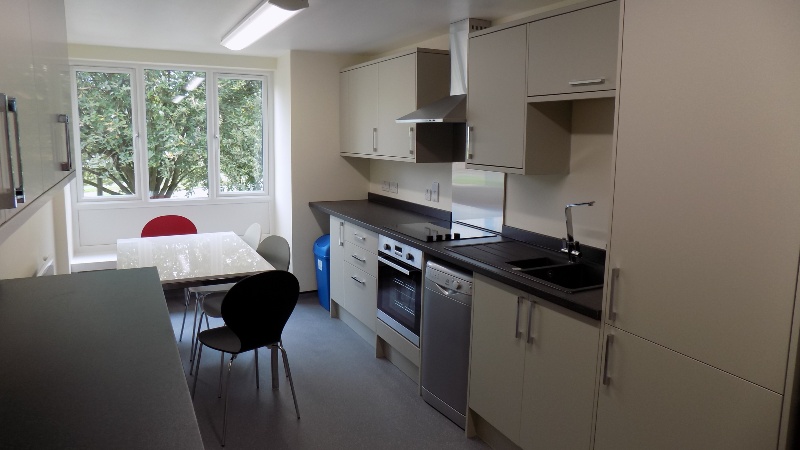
[466,25,528,171]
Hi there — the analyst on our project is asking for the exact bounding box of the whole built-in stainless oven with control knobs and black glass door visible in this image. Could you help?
[378,236,425,347]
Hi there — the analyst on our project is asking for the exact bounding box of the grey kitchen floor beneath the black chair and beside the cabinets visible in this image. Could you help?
[167,292,488,449]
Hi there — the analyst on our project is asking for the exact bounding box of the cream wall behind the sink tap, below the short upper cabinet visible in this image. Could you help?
[505,98,614,248]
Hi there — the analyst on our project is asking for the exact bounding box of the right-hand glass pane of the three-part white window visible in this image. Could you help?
[218,78,264,192]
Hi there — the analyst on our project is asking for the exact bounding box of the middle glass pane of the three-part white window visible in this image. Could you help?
[145,70,208,198]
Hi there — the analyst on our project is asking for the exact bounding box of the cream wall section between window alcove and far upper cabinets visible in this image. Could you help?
[286,51,369,291]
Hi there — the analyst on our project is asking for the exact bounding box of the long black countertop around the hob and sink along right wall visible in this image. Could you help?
[309,200,603,320]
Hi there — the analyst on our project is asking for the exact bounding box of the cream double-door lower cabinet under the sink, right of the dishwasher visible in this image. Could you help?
[469,274,600,449]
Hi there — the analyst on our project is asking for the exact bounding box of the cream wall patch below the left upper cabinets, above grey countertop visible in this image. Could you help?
[0,201,56,279]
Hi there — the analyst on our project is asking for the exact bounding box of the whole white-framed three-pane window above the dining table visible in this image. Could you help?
[73,66,268,202]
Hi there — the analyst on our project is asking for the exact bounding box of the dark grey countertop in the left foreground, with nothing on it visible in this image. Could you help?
[0,268,203,449]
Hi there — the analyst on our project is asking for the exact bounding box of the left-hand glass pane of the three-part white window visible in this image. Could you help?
[75,71,136,198]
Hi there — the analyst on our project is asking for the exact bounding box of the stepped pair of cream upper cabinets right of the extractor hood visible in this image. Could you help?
[466,1,619,175]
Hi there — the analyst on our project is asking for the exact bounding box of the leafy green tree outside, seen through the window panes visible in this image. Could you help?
[76,70,264,198]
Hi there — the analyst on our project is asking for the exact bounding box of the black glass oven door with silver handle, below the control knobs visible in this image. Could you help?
[378,253,422,347]
